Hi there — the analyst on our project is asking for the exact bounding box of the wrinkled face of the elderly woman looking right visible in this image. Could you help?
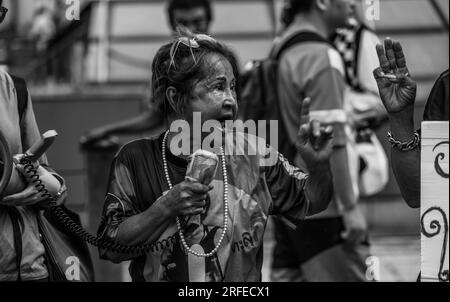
[185,54,238,125]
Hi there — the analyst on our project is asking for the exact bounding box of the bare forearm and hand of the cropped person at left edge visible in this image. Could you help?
[1,158,61,207]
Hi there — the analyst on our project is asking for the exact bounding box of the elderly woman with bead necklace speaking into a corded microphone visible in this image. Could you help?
[99,33,333,282]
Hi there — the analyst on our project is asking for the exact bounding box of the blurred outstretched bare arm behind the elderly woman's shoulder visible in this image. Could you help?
[80,106,163,145]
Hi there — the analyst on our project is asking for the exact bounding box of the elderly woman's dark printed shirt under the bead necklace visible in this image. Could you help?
[99,134,310,282]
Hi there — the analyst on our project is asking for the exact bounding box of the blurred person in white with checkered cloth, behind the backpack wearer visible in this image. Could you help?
[331,0,389,197]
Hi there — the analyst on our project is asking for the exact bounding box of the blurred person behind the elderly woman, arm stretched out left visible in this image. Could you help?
[80,0,213,146]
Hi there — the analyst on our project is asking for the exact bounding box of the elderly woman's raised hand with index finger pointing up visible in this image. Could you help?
[296,98,333,170]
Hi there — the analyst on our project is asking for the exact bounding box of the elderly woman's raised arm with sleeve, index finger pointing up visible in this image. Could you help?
[265,99,333,227]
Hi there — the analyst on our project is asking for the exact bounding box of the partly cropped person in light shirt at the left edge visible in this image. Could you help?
[0,0,66,281]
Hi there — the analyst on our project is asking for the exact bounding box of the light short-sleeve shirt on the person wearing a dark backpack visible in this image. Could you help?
[274,25,358,217]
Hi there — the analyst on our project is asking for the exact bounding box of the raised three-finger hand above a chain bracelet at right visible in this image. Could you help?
[373,39,417,114]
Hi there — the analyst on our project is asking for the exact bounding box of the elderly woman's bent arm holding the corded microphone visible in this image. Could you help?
[98,155,210,263]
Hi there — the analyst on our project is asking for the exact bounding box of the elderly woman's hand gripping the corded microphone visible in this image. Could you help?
[159,180,213,217]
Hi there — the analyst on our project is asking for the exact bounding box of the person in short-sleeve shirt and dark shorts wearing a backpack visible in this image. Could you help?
[271,0,370,282]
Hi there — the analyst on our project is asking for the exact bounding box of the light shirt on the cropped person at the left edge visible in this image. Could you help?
[0,71,48,282]
